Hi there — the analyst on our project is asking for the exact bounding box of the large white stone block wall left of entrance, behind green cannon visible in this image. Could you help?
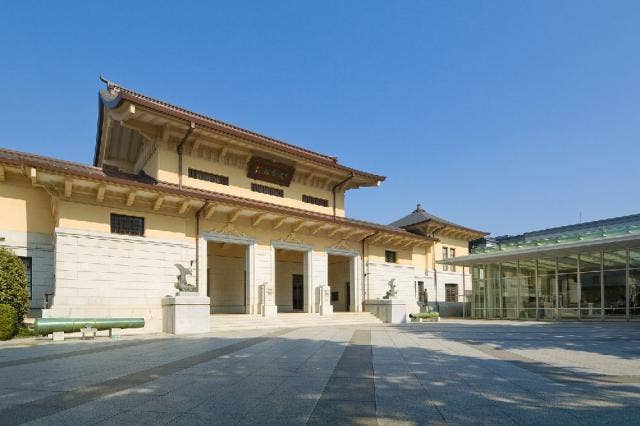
[43,228,195,333]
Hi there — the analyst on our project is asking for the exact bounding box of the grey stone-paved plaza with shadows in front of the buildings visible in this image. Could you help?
[0,321,640,425]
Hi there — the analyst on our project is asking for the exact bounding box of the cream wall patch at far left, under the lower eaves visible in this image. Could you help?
[0,180,55,234]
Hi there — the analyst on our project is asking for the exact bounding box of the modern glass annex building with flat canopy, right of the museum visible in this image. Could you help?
[440,214,640,320]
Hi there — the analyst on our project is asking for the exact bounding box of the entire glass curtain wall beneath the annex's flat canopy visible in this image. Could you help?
[470,249,640,320]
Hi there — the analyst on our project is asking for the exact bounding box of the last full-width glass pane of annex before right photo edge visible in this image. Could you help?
[602,250,627,316]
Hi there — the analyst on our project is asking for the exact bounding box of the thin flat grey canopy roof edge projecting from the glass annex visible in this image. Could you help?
[437,234,640,266]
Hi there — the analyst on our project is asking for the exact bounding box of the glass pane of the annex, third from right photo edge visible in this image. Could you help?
[580,253,602,318]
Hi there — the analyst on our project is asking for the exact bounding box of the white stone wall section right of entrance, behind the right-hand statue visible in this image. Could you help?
[365,262,420,313]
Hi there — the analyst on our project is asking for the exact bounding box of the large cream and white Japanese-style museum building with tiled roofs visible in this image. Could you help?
[0,82,486,332]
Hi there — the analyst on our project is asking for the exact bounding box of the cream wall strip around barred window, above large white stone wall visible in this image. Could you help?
[58,200,195,241]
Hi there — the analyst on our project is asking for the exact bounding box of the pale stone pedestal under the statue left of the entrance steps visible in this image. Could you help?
[162,292,210,334]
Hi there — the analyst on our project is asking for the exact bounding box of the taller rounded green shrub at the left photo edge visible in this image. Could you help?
[0,248,29,324]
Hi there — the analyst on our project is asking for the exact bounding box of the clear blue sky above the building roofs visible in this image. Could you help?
[0,0,640,234]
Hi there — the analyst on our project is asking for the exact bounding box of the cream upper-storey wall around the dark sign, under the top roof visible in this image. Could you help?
[153,147,345,217]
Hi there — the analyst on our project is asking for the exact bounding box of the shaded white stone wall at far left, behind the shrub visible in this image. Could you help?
[0,229,54,310]
